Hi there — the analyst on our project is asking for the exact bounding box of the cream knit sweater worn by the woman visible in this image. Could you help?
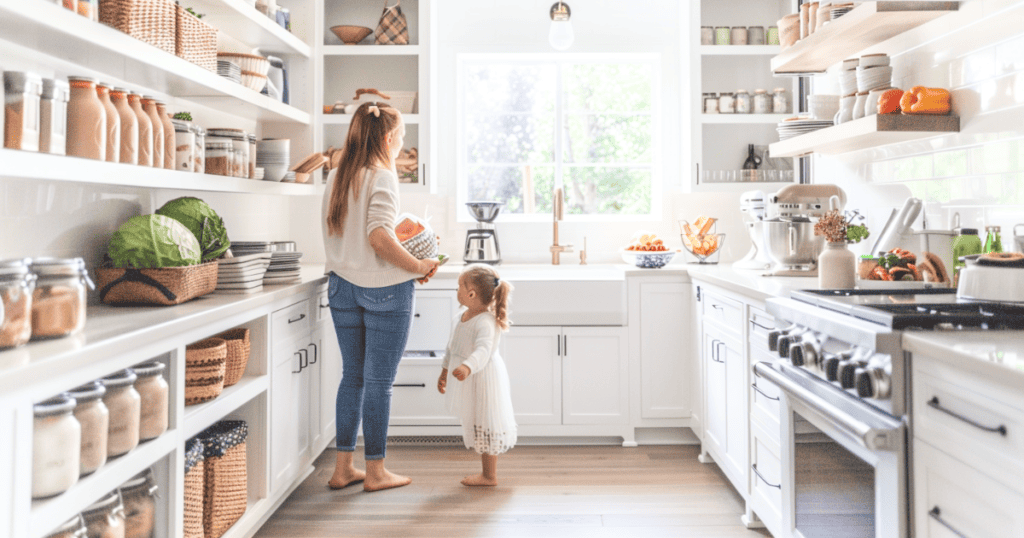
[321,168,423,288]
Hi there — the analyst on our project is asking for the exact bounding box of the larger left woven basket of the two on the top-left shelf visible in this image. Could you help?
[99,0,175,54]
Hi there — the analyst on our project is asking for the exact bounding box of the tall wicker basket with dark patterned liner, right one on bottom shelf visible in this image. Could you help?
[199,420,249,538]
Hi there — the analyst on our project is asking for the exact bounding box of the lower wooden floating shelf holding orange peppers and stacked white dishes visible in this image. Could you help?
[768,114,959,157]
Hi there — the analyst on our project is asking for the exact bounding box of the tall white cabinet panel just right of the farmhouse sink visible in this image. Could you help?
[639,283,690,418]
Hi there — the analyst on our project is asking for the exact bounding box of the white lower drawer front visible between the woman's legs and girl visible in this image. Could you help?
[390,358,459,426]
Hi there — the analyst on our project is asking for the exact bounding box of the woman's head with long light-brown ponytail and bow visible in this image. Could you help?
[327,102,401,236]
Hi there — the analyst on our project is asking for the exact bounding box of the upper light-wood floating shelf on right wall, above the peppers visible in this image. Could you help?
[771,1,959,75]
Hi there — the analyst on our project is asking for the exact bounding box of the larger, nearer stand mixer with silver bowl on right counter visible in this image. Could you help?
[762,184,846,277]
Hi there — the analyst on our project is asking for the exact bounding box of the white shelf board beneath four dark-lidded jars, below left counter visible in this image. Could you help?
[30,430,178,538]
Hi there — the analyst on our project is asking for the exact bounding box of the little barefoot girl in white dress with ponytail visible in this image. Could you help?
[437,264,516,486]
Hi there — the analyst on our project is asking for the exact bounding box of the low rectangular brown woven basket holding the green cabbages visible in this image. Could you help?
[96,261,219,305]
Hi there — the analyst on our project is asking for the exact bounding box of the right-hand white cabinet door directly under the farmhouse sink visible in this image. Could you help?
[561,327,630,424]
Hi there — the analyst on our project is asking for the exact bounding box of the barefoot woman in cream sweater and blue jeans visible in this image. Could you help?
[323,102,437,491]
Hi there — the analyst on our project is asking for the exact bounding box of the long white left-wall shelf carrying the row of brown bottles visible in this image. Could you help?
[0,149,316,196]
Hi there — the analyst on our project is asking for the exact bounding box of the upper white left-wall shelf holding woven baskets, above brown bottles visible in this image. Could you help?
[0,0,310,125]
